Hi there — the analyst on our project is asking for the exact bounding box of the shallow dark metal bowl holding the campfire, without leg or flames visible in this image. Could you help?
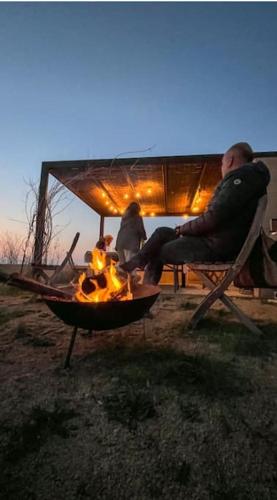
[43,285,160,330]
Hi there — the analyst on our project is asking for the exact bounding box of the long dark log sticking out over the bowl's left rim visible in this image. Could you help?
[0,271,72,299]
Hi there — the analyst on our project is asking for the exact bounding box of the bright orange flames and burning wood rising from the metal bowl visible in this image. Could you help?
[75,248,133,302]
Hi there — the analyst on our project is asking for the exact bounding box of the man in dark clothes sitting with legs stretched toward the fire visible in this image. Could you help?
[120,142,270,284]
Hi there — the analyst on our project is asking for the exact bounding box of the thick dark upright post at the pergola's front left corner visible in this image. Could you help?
[33,163,49,265]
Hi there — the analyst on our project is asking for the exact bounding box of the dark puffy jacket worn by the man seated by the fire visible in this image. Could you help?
[181,161,270,260]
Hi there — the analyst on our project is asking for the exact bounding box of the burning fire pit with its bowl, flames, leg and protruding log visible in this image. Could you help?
[0,249,160,368]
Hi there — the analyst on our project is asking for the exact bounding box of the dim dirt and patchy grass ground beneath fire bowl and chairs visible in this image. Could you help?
[0,286,277,500]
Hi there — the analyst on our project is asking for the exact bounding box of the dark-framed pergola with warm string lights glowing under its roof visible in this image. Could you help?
[34,153,274,265]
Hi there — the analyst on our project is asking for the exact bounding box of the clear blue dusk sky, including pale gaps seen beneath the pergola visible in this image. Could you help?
[0,2,277,262]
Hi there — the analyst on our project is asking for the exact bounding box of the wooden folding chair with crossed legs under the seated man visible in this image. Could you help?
[186,195,267,334]
